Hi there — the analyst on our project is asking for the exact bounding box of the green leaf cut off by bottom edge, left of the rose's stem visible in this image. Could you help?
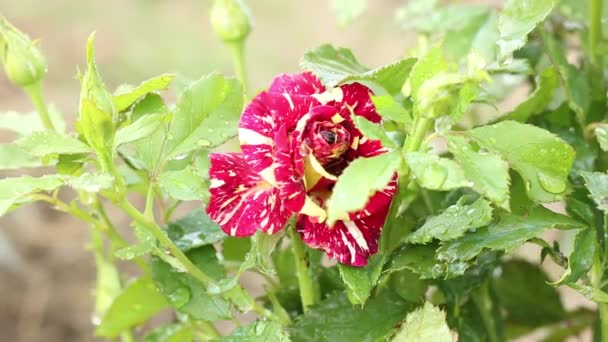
[213,321,291,342]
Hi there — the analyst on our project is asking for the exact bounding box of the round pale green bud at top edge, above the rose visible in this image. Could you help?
[211,0,252,42]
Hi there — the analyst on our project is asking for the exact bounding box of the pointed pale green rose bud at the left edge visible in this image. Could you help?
[0,18,47,87]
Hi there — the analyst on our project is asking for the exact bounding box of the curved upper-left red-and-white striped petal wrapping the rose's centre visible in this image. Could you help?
[239,92,318,185]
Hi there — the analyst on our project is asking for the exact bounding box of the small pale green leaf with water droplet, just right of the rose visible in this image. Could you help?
[405,152,472,191]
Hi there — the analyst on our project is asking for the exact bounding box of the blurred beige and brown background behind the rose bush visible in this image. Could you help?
[0,0,588,342]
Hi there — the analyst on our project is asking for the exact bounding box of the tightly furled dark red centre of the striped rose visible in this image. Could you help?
[307,121,350,165]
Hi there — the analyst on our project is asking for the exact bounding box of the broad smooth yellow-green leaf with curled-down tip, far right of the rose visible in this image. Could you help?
[469,121,574,202]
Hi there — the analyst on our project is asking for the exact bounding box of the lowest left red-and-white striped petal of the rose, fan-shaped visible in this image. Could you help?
[207,153,291,236]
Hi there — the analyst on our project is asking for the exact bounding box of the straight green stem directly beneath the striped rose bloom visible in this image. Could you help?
[289,227,317,312]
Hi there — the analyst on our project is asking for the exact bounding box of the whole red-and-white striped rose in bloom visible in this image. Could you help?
[207,73,396,266]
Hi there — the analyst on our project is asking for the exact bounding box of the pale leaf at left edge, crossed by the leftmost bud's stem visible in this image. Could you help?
[0,104,65,136]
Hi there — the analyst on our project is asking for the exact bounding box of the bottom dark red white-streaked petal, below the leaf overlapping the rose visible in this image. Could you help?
[296,206,388,266]
